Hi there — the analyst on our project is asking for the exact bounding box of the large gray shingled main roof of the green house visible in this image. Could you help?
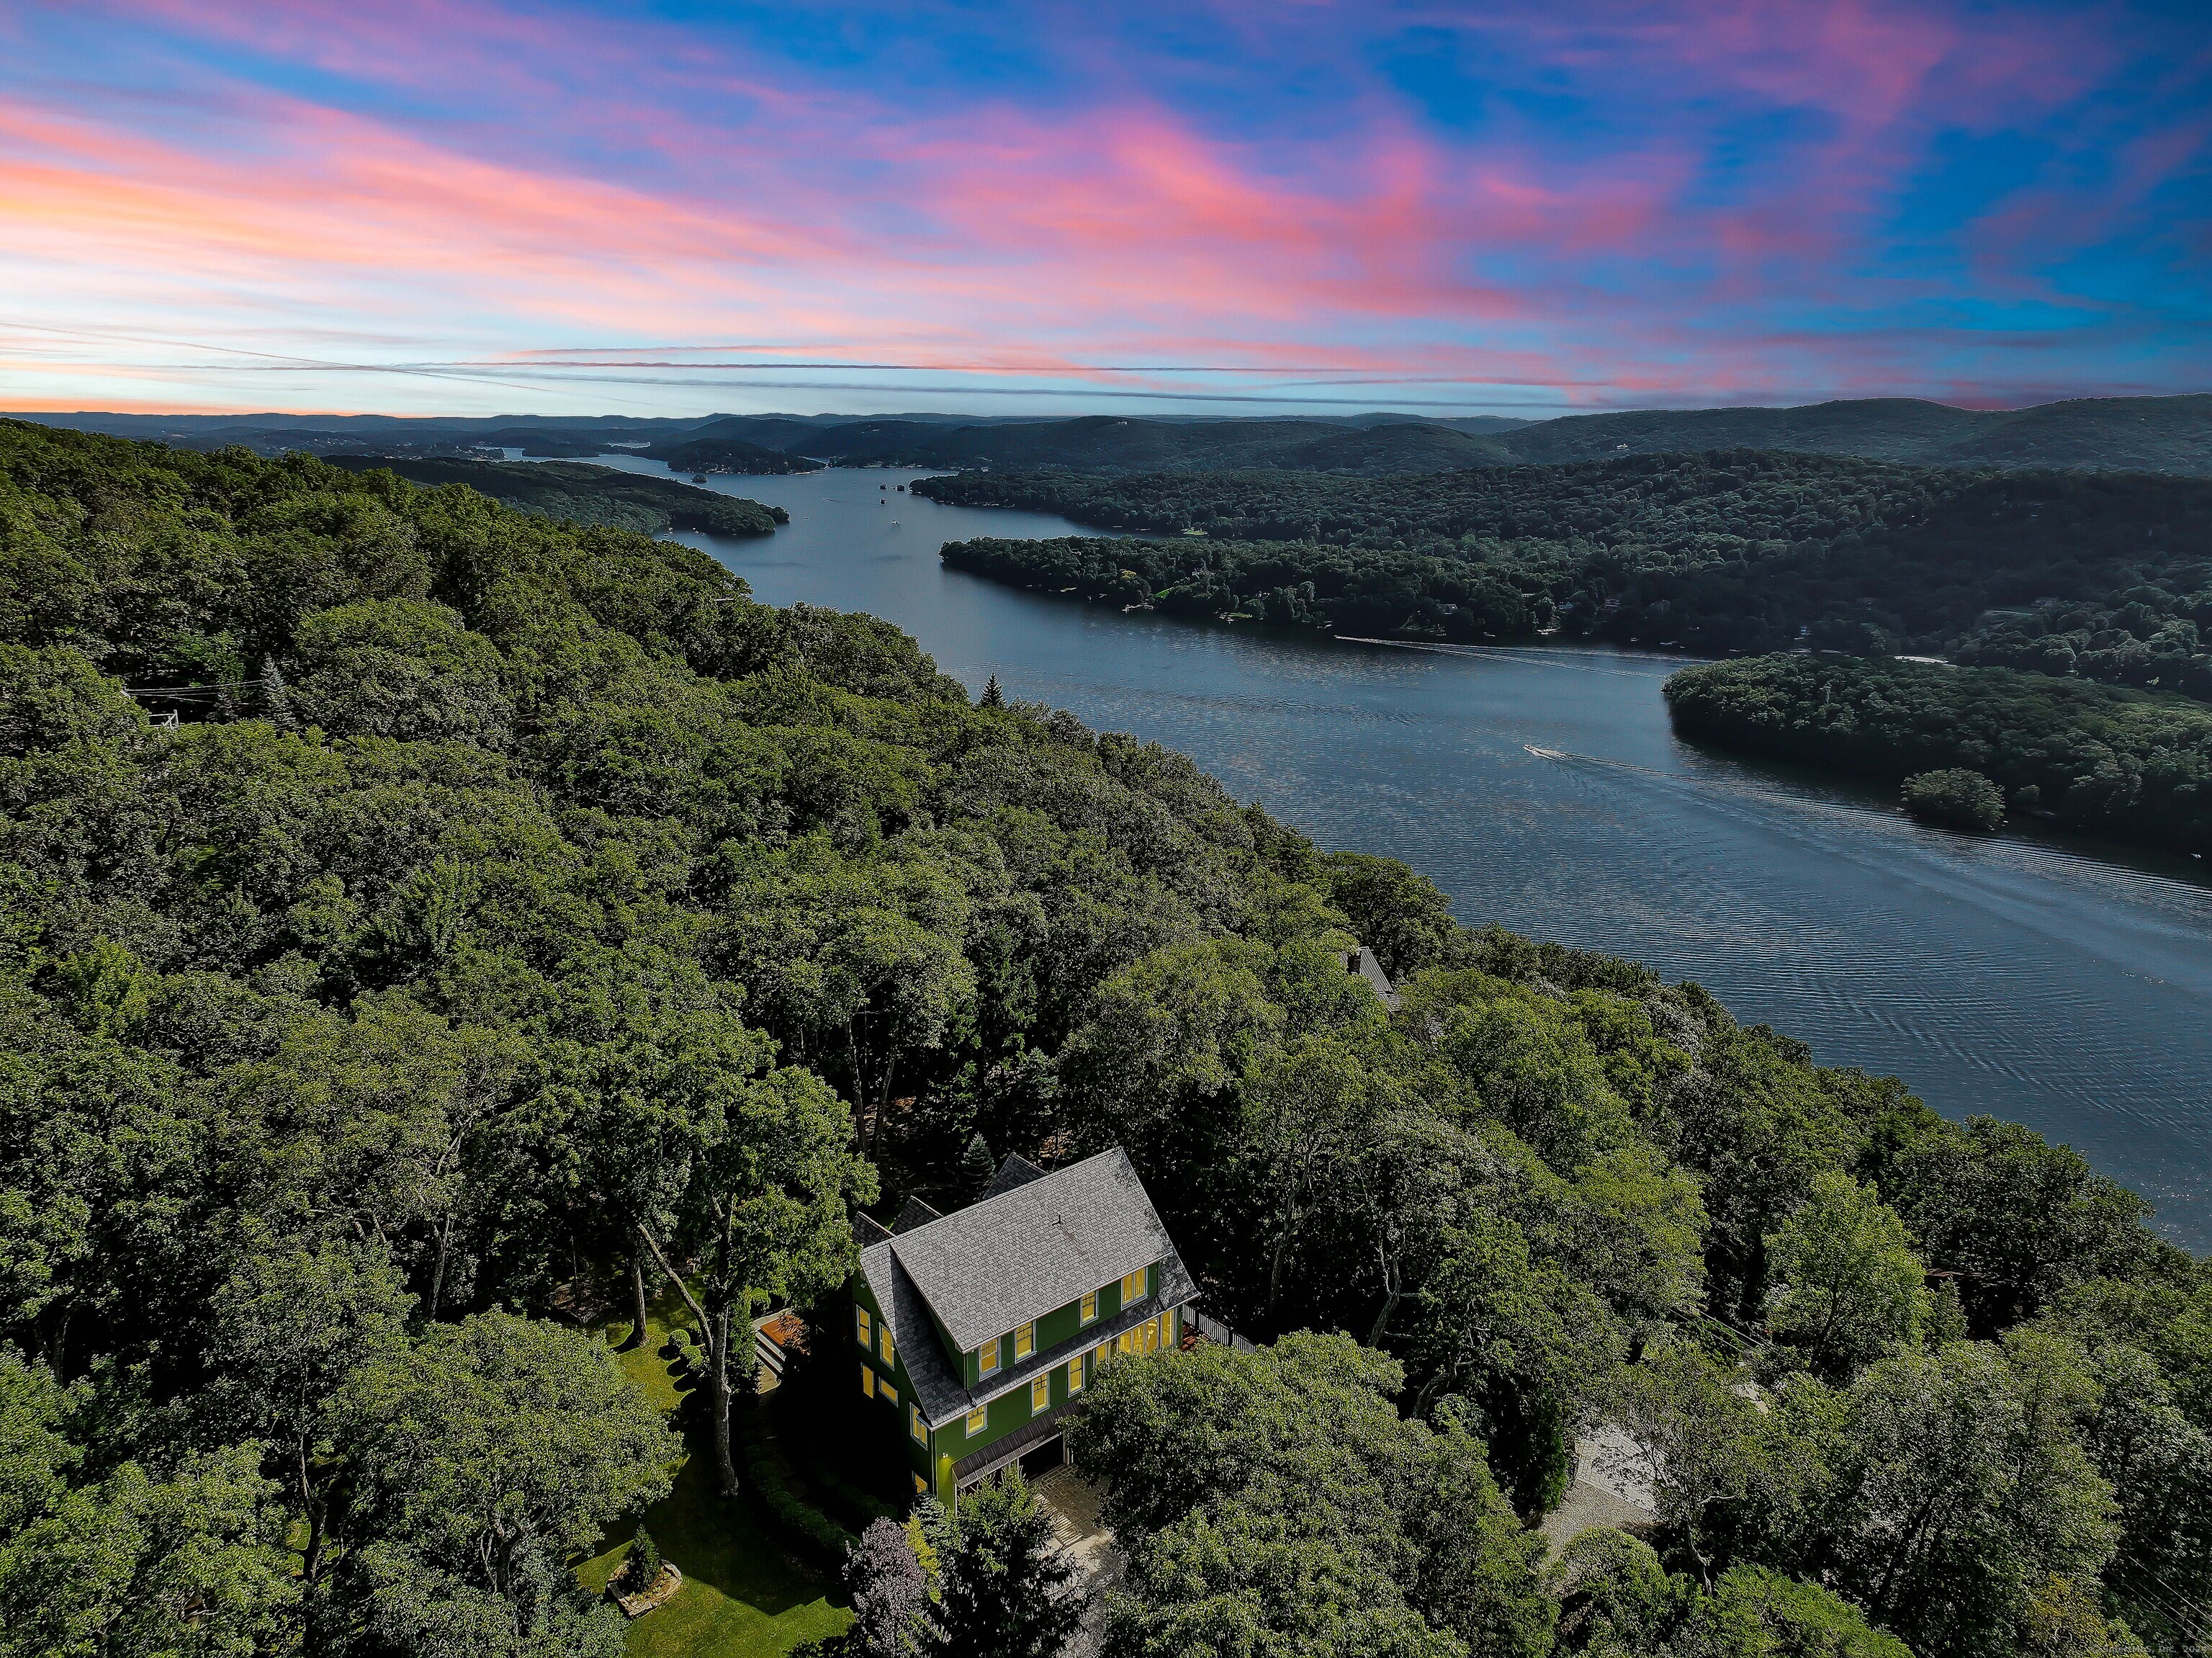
[889,1147,1174,1354]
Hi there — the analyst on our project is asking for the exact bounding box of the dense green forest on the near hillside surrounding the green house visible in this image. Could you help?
[0,423,2212,1658]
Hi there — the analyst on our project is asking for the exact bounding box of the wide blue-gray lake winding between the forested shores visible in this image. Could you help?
[548,456,2212,1250]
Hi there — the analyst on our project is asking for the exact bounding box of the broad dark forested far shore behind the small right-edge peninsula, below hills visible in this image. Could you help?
[916,452,2212,695]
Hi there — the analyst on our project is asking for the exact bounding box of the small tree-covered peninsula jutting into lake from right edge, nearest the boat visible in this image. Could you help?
[1665,655,2212,852]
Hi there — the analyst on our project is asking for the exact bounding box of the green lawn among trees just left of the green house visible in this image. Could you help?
[577,1293,852,1658]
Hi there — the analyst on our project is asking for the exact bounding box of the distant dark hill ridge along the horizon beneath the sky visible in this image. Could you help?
[17,394,2212,476]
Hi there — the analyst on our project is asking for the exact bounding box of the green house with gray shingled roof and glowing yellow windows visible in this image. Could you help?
[852,1149,1197,1503]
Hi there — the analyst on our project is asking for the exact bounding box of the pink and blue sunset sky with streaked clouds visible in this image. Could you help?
[0,0,2212,414]
